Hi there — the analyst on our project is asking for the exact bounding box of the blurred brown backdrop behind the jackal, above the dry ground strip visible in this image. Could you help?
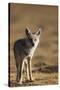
[10,3,58,86]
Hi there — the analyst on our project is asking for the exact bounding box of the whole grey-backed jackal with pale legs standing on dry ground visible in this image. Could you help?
[13,28,41,84]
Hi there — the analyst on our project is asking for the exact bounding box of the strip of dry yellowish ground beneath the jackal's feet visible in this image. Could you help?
[10,72,58,87]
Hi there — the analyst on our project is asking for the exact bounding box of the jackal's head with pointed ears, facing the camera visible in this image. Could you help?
[25,28,41,46]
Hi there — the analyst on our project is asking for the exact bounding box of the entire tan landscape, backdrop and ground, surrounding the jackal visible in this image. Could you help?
[9,4,58,87]
